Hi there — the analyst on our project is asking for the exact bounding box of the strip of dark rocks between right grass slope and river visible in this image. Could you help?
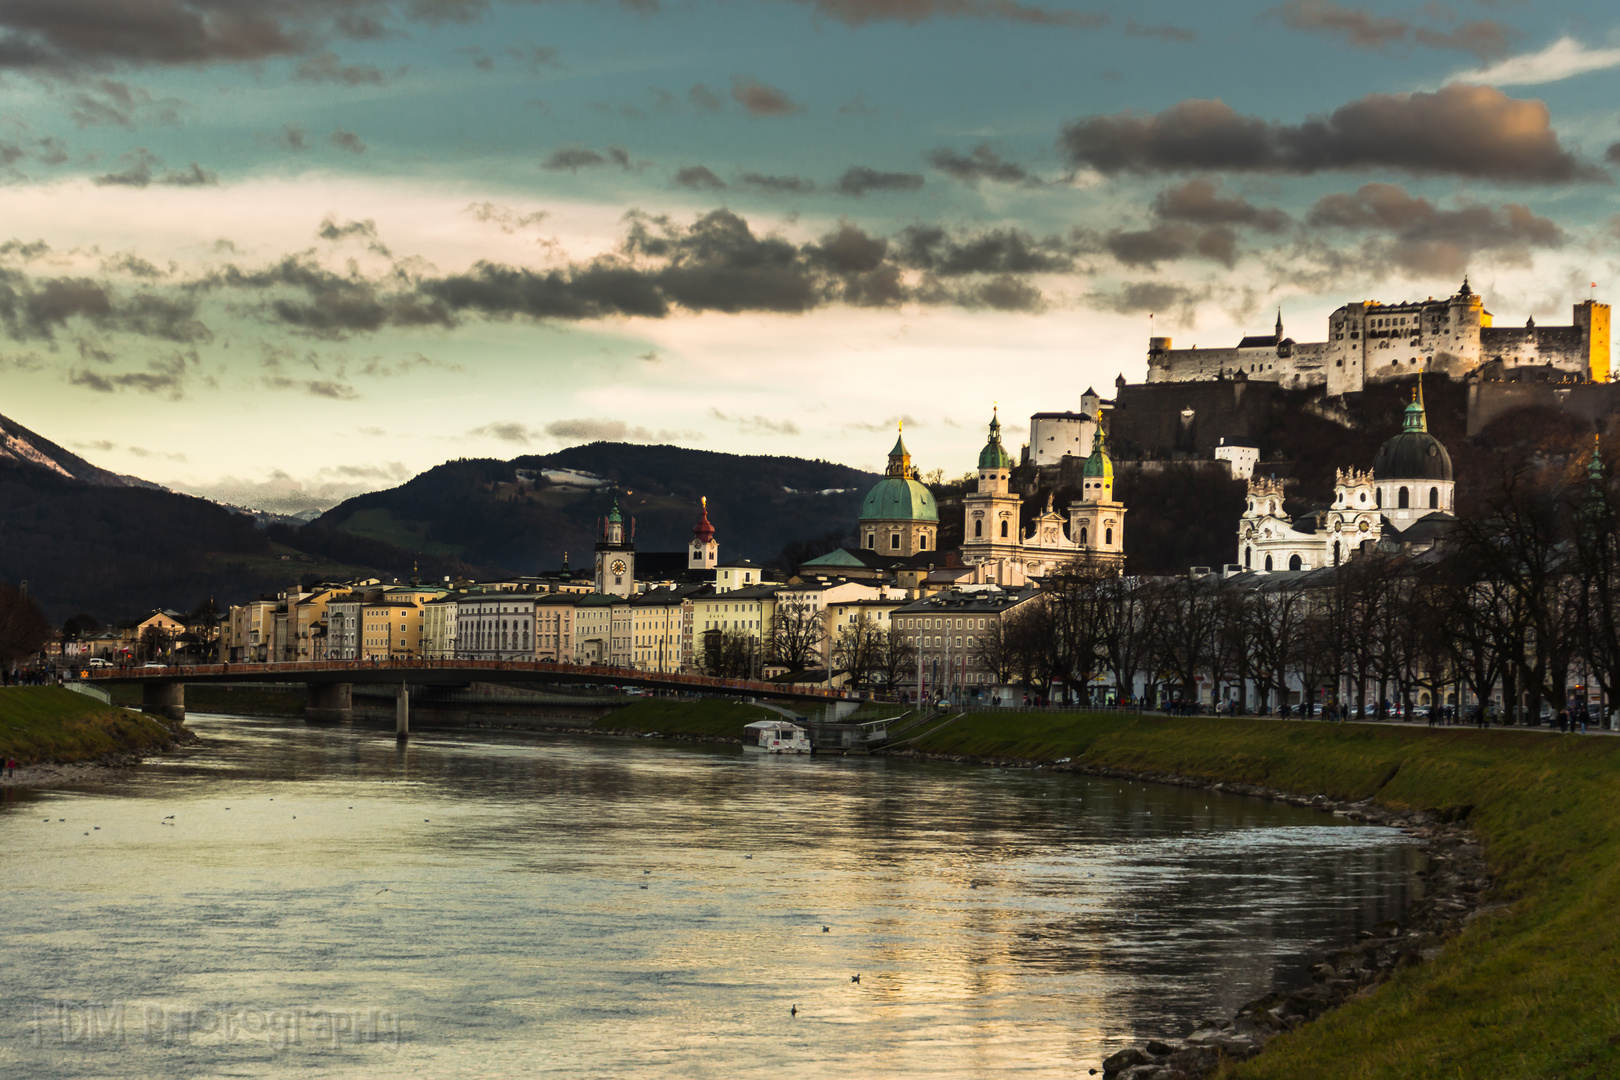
[902,751,1507,1080]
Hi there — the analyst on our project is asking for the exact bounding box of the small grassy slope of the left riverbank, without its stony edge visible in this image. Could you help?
[0,687,173,766]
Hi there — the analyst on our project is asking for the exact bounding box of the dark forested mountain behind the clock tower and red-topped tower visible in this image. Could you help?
[307,442,878,573]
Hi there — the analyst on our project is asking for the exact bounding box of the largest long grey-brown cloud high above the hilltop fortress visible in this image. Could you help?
[1059,84,1607,183]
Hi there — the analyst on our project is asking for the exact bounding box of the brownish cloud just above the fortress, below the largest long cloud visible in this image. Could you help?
[1306,183,1568,274]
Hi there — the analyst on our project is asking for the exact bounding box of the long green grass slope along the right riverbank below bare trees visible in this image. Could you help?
[917,714,1620,1080]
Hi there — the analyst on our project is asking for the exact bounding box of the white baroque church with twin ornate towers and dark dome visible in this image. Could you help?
[1238,384,1456,570]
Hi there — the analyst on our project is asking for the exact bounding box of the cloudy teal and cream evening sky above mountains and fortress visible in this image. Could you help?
[0,0,1620,512]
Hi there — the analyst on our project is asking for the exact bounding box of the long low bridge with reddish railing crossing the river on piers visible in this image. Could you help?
[79,661,855,738]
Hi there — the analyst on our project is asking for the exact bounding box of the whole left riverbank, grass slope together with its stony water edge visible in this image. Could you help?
[0,687,194,787]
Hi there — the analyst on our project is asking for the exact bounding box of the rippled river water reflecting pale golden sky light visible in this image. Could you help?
[0,716,1422,1080]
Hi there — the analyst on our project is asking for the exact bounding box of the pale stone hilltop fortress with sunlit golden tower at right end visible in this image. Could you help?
[1147,279,1609,395]
